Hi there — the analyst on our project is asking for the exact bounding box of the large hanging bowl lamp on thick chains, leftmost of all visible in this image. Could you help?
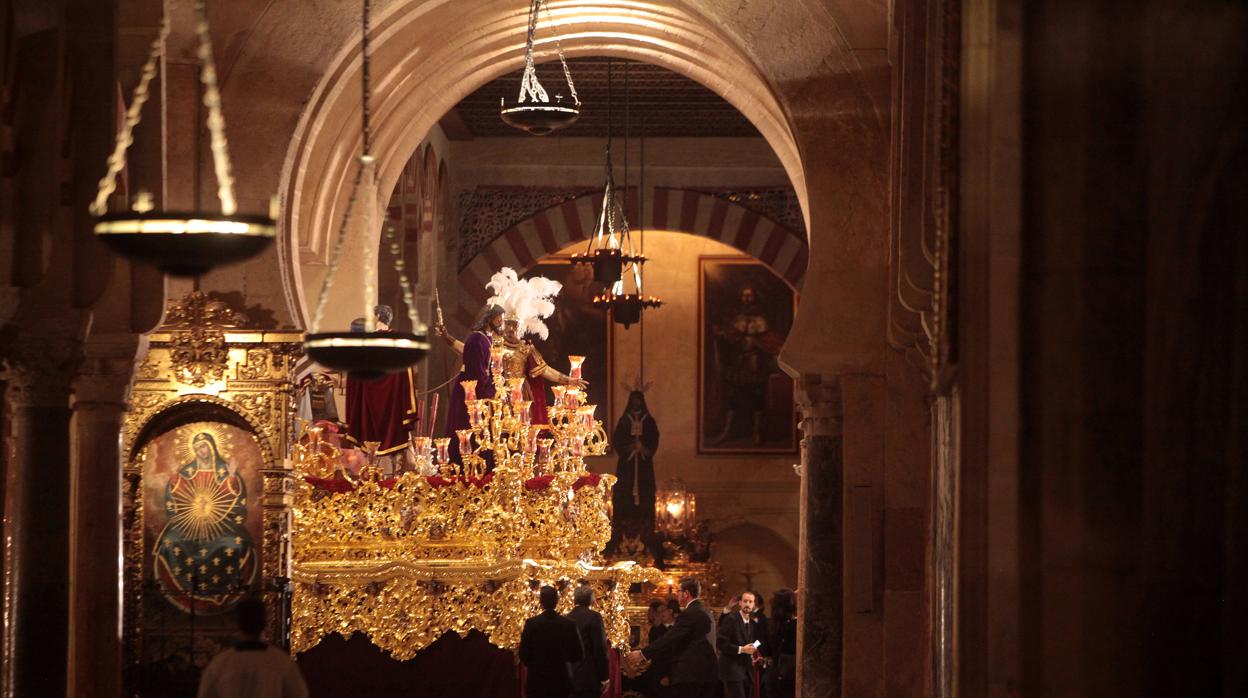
[90,0,277,276]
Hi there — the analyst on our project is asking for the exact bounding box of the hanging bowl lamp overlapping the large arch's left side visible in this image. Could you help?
[303,0,429,380]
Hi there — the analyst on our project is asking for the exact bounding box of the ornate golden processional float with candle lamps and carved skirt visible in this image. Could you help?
[291,347,661,661]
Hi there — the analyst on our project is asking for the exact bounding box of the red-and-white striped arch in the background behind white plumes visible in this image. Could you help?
[456,187,807,323]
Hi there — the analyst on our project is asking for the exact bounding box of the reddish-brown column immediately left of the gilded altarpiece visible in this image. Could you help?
[67,335,137,697]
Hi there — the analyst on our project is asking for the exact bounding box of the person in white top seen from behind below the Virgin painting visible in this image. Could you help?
[198,599,308,698]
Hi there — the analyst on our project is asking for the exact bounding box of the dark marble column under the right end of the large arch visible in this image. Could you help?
[797,377,845,698]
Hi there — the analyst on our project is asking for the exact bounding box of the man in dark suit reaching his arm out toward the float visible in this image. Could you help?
[629,577,716,698]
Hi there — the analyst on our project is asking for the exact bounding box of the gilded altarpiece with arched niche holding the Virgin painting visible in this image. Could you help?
[122,292,302,694]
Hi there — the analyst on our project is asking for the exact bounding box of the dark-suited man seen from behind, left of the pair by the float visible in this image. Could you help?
[520,587,583,698]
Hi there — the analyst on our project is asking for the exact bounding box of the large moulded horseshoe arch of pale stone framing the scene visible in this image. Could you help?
[281,0,807,332]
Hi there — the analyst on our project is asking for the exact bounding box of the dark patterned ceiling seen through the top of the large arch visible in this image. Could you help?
[442,57,760,140]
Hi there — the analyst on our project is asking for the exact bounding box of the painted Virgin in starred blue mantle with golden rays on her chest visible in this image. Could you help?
[152,432,256,613]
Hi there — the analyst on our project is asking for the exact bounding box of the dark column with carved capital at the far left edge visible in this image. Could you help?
[4,337,80,697]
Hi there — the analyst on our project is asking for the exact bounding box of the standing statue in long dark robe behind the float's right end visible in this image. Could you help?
[612,390,659,531]
